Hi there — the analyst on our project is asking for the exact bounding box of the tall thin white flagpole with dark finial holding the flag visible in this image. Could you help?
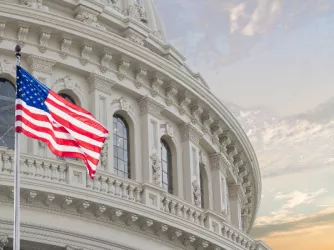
[13,45,21,250]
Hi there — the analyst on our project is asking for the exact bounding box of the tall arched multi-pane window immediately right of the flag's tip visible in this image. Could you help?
[113,114,131,178]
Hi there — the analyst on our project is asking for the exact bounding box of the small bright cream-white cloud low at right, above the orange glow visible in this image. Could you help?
[275,188,327,209]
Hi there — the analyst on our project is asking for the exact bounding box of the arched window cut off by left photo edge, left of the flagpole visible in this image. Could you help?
[0,78,15,149]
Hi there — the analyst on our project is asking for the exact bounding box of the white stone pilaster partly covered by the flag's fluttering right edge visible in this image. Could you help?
[87,73,116,172]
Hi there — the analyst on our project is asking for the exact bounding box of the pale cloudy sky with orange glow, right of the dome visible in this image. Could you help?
[156,0,334,250]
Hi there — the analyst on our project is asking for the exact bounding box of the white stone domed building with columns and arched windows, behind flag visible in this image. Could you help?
[0,0,270,250]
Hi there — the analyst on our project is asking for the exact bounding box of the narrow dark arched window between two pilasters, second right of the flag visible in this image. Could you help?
[161,139,173,194]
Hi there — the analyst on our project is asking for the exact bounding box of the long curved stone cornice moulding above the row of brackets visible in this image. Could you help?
[0,3,261,231]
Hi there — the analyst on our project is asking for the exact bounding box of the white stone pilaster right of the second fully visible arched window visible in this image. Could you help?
[179,124,203,206]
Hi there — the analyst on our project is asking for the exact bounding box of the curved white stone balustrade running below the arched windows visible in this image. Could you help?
[0,148,269,250]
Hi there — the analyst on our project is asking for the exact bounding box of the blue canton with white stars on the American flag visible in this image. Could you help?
[16,66,50,113]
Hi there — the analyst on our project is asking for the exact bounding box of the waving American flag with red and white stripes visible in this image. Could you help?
[15,66,108,179]
